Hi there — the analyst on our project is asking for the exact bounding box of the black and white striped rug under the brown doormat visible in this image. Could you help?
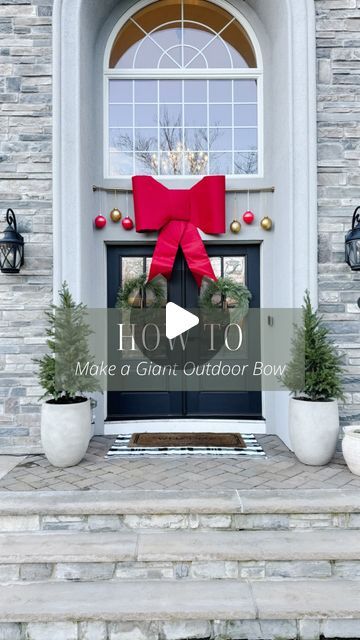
[105,433,265,458]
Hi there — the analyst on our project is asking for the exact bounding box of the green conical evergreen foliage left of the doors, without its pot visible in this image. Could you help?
[34,282,100,404]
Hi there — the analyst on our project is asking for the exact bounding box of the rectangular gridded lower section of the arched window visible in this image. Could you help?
[109,79,258,177]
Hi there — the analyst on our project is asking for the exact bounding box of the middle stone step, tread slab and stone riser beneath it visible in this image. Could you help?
[0,529,360,582]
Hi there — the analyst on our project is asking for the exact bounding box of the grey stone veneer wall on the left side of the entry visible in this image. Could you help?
[0,0,52,452]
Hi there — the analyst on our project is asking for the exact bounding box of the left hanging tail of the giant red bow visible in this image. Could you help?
[148,220,184,281]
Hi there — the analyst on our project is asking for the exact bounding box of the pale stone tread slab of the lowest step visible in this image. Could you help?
[0,580,360,622]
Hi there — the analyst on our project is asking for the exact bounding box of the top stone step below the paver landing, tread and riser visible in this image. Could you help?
[0,489,360,532]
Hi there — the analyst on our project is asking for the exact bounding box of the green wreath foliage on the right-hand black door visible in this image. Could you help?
[200,278,252,317]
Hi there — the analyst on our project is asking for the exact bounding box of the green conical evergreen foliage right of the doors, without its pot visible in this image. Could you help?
[282,291,343,402]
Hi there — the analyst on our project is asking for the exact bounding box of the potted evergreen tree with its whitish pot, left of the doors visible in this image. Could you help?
[35,283,100,467]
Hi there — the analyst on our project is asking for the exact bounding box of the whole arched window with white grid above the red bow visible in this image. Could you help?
[105,0,262,178]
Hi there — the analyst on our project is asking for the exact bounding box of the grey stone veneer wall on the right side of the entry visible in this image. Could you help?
[315,0,360,424]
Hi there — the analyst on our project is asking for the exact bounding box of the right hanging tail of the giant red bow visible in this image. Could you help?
[180,223,217,288]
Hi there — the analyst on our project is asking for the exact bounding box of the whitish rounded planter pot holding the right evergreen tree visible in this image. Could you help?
[289,398,339,465]
